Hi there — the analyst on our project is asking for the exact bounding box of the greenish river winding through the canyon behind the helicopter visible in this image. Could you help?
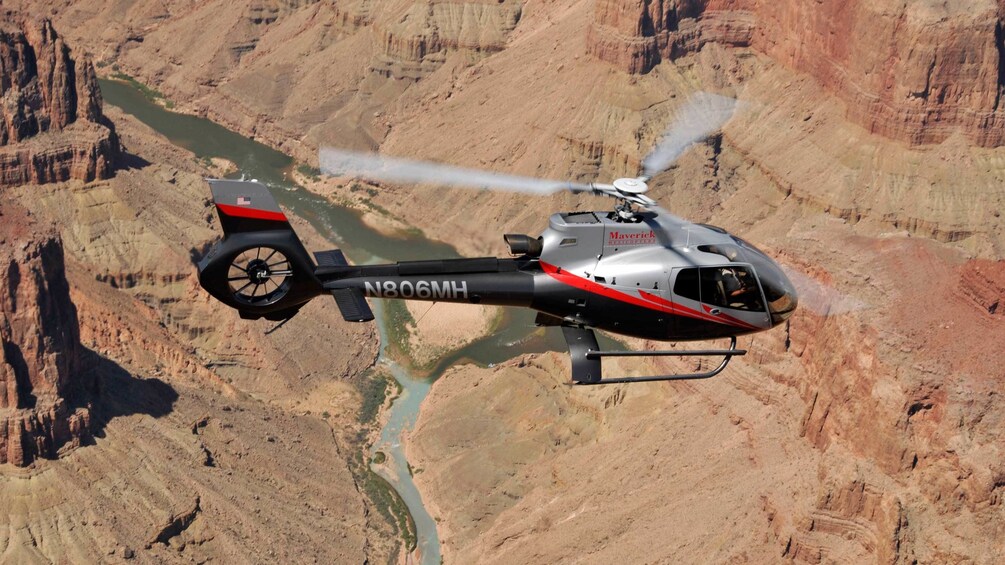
[98,78,618,565]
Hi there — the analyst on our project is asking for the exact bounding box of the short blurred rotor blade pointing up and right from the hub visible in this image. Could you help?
[642,92,737,178]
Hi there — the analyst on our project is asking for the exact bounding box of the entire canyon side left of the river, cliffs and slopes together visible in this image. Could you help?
[0,7,391,563]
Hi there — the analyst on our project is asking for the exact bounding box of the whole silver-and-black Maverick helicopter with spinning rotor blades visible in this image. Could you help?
[198,92,798,384]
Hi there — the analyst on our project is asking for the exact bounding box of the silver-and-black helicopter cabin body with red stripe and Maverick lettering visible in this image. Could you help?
[532,210,797,340]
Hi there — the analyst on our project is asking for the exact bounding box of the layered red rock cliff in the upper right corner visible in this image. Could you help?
[588,0,1005,147]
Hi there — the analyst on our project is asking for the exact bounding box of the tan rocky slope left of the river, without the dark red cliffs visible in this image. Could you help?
[0,102,387,563]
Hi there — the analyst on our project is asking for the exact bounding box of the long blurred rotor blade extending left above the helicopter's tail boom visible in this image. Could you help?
[319,147,591,194]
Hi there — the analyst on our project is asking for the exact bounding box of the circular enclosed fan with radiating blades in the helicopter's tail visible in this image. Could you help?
[227,246,293,306]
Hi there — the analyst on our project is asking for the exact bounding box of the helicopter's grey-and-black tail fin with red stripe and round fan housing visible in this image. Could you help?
[199,180,324,320]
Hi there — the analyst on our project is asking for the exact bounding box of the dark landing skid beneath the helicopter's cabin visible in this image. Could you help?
[562,326,747,384]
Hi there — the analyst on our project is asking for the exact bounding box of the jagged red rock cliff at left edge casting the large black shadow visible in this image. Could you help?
[0,200,90,466]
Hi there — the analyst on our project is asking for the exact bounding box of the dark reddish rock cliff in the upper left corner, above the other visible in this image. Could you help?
[0,13,120,186]
